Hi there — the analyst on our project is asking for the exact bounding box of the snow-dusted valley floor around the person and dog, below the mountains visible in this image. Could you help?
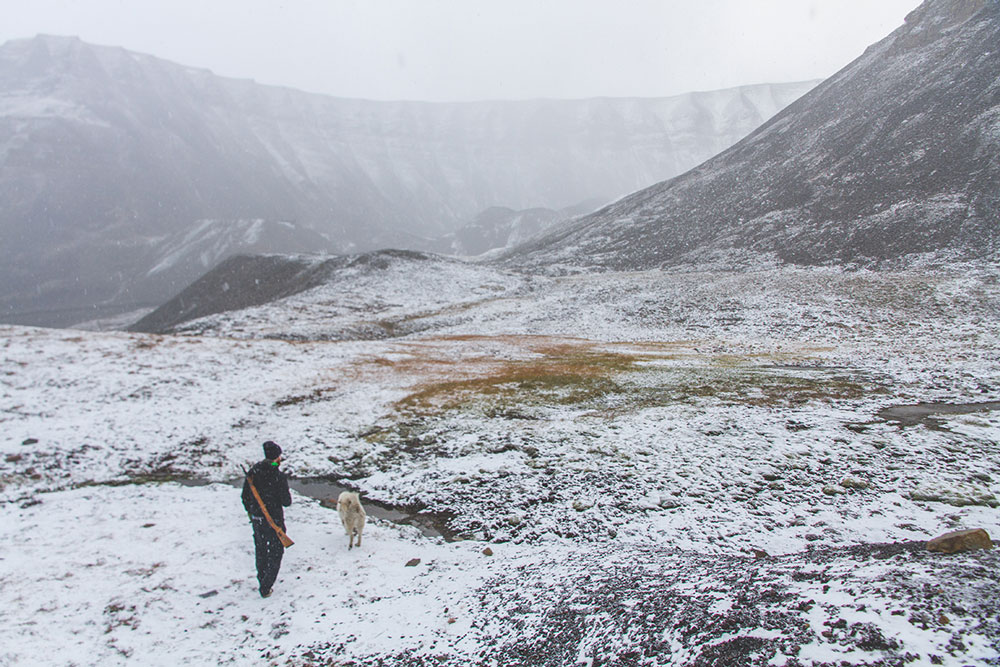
[0,260,1000,665]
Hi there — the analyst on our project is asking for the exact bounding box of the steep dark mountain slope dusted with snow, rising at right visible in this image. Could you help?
[512,0,1000,268]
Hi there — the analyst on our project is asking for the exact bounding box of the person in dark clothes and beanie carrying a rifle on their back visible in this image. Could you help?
[243,440,292,598]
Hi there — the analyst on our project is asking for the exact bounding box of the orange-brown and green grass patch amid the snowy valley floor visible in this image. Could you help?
[336,335,866,418]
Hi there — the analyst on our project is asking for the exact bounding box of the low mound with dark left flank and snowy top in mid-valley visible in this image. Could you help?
[129,250,530,340]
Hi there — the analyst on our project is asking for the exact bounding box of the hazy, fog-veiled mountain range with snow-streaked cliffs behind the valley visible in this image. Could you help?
[0,37,813,323]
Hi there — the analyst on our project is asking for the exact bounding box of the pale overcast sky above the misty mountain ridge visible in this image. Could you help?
[0,0,920,101]
